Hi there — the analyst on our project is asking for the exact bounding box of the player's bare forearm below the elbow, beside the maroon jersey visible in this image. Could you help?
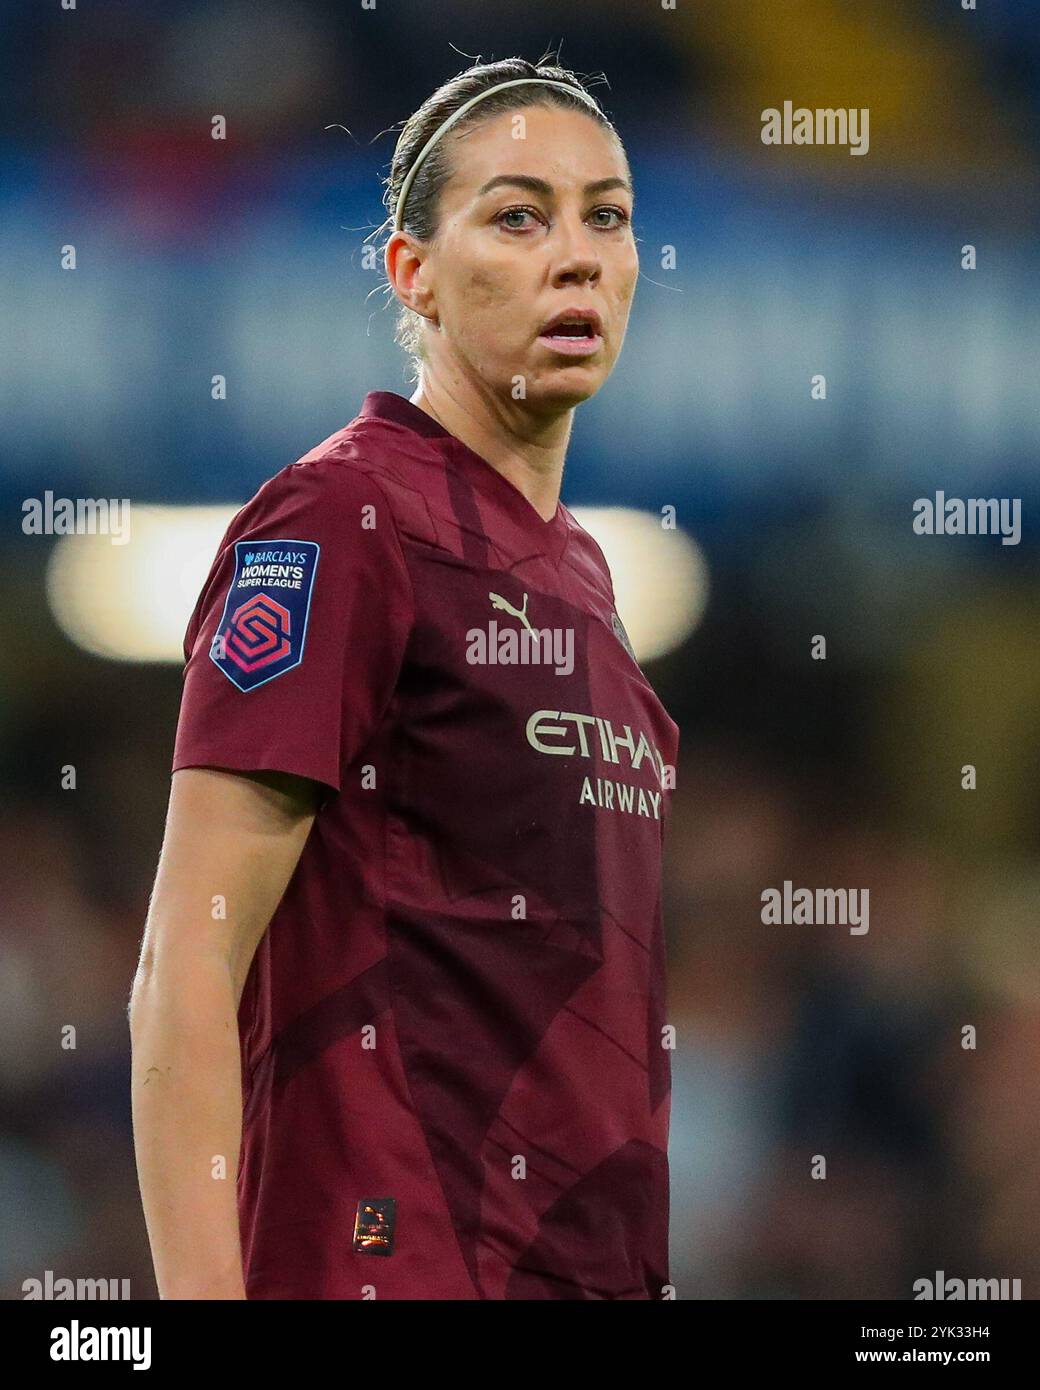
[129,956,246,1298]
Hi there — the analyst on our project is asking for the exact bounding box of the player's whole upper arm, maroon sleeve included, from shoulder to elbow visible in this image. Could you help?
[149,460,414,995]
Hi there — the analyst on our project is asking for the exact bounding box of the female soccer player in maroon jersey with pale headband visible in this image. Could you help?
[131,58,677,1298]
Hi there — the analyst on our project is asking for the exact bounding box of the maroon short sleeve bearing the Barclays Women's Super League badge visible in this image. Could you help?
[172,460,414,791]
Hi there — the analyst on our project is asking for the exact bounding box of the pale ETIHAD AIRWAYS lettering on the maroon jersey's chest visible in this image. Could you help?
[527,709,676,820]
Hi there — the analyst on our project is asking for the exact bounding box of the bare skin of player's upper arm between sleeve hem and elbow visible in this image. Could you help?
[140,767,318,1002]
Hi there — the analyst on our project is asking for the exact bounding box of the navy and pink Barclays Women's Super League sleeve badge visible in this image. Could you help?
[210,541,314,691]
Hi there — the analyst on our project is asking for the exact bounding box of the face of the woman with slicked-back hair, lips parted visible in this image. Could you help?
[403,106,640,411]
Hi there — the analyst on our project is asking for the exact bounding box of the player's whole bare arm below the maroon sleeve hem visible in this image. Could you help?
[129,767,317,1298]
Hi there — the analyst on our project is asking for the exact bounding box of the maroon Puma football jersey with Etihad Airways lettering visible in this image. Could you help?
[172,391,679,1298]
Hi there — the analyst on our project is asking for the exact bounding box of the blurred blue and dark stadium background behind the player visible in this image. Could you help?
[0,0,1040,1298]
